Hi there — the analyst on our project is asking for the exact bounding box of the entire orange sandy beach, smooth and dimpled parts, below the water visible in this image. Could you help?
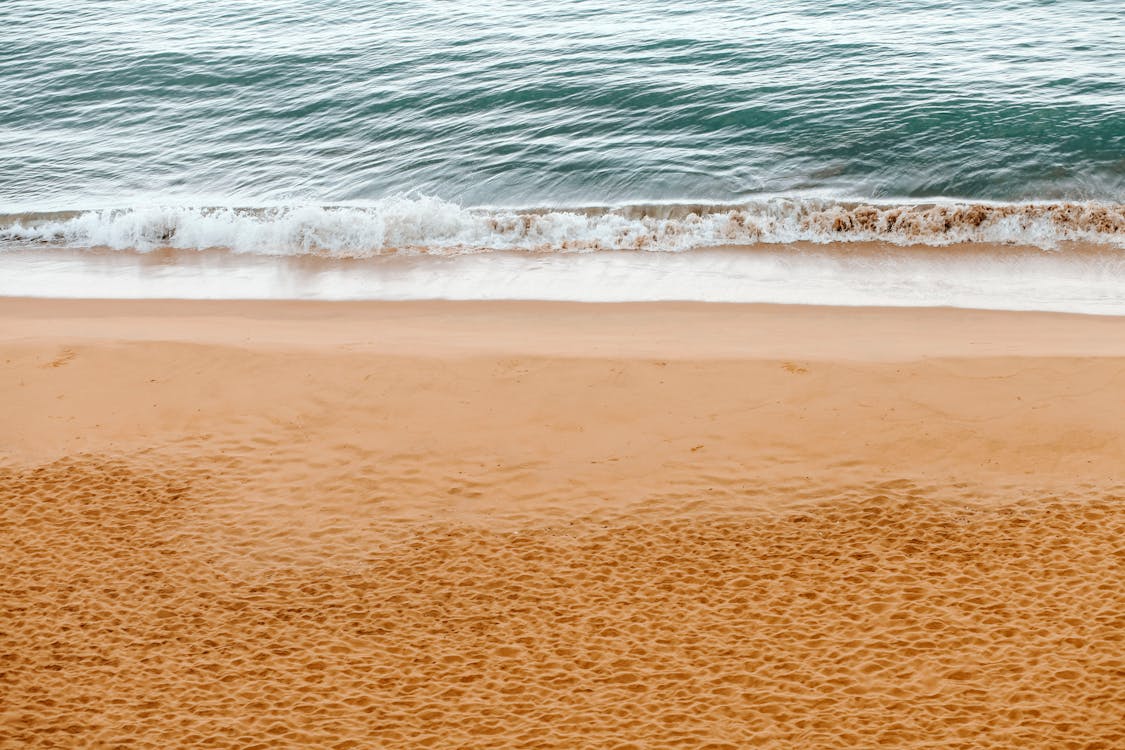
[0,300,1125,748]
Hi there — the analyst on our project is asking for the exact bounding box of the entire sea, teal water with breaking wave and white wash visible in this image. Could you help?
[0,0,1125,314]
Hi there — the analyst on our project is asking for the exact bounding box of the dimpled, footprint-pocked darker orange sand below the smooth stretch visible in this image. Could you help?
[0,457,1125,748]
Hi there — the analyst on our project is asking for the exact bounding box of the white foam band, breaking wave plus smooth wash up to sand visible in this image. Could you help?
[0,197,1125,315]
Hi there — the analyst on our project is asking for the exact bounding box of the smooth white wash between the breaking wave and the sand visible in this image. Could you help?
[0,242,1125,315]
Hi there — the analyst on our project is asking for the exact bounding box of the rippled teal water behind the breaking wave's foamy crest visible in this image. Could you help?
[0,0,1125,214]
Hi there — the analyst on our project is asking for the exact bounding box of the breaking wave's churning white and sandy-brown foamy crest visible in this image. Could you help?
[0,197,1125,257]
